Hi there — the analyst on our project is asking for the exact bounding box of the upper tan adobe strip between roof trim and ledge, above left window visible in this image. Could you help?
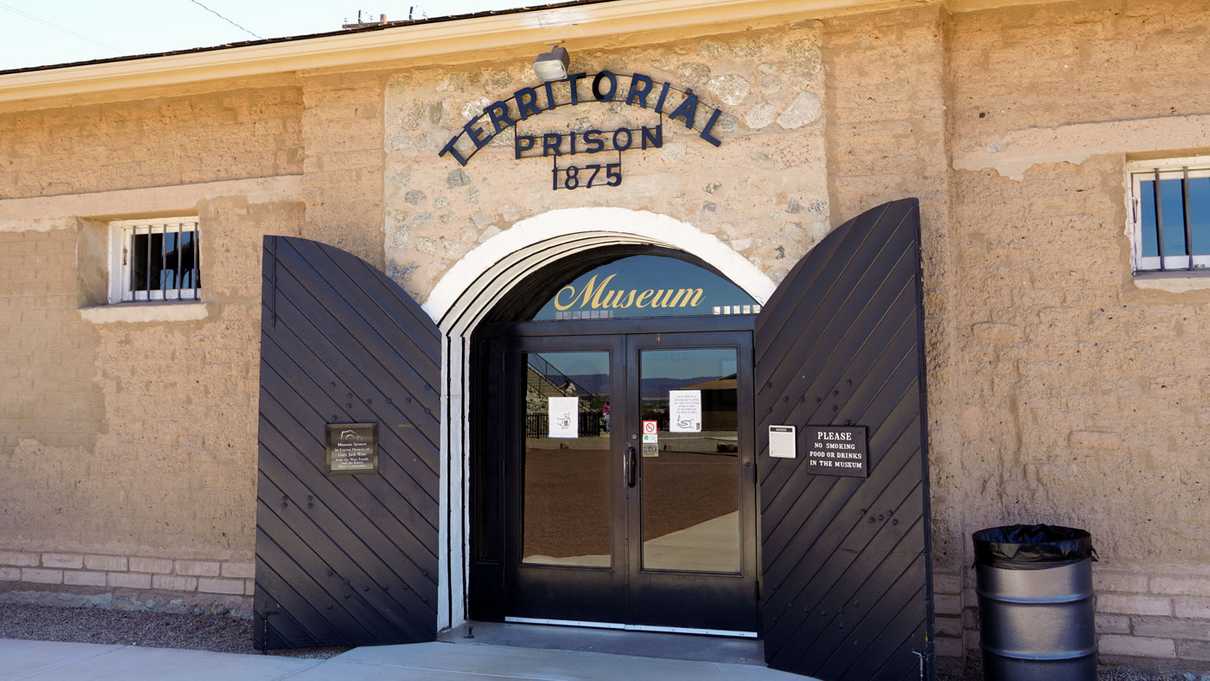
[0,87,303,198]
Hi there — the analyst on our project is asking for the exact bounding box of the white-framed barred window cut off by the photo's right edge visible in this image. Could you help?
[1128,157,1210,272]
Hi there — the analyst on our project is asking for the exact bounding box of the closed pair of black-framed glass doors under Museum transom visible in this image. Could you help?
[508,331,757,631]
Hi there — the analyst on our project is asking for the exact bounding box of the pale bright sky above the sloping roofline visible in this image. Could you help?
[0,0,563,70]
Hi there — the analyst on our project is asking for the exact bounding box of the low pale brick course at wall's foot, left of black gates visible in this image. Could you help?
[0,549,255,616]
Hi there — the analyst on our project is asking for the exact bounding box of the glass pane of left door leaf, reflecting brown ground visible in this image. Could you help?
[522,352,613,567]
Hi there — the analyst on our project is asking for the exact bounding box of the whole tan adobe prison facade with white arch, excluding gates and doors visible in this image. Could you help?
[0,0,1210,670]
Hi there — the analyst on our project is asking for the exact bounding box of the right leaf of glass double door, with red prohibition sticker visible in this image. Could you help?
[620,331,757,635]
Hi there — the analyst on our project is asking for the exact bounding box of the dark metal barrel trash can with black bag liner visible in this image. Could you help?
[973,525,1096,681]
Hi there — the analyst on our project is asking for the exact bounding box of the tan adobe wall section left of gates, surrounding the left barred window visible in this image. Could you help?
[0,87,303,607]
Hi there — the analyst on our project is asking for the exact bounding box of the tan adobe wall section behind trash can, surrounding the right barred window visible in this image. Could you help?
[949,1,1210,660]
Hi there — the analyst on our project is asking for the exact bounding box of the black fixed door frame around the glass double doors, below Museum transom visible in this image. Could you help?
[463,314,764,636]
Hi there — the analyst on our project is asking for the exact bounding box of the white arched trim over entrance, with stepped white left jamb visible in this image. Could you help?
[424,208,776,629]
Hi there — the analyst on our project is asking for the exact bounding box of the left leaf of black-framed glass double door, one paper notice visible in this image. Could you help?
[505,336,629,622]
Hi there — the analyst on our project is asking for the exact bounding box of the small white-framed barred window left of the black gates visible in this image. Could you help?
[110,218,202,302]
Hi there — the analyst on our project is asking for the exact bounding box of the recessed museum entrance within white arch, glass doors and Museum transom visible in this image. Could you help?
[468,246,760,636]
